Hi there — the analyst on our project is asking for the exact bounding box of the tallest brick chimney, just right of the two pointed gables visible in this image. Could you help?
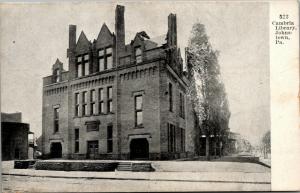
[115,5,125,55]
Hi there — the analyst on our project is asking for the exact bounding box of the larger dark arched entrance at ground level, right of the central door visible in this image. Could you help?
[130,138,149,160]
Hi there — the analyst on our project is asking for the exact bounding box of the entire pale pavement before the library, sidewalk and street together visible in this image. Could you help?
[2,161,271,191]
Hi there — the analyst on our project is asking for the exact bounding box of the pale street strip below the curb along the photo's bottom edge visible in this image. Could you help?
[2,175,271,192]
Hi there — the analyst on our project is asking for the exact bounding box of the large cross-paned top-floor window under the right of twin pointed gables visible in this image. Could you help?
[98,47,113,72]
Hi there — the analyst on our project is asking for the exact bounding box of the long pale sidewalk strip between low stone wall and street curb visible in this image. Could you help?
[2,169,271,184]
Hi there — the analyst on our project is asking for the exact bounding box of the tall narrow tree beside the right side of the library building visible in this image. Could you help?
[187,23,230,160]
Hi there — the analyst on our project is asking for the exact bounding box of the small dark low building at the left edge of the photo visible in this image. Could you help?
[1,112,29,161]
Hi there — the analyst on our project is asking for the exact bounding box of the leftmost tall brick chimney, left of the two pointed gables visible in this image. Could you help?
[67,25,76,79]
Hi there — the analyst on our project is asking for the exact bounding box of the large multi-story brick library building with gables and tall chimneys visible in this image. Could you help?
[42,5,195,159]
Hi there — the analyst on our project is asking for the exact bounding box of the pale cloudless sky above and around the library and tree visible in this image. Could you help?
[0,1,270,144]
